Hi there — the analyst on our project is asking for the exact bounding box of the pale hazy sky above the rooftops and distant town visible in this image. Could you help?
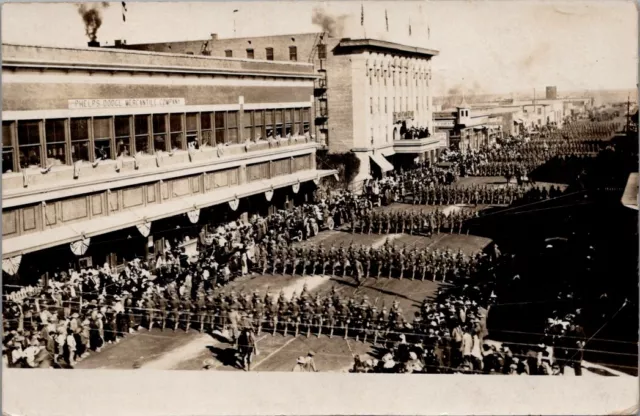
[2,0,638,95]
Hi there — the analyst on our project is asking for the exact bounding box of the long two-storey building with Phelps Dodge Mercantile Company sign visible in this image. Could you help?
[2,44,335,275]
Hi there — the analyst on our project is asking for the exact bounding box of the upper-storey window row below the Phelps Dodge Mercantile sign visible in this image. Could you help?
[2,108,309,173]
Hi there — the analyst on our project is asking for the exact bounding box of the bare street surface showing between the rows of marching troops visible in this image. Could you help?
[77,204,490,372]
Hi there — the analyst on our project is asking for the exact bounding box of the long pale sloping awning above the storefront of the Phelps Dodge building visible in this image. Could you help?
[2,169,337,259]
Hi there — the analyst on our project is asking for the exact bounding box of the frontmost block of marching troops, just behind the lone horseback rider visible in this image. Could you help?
[132,276,487,352]
